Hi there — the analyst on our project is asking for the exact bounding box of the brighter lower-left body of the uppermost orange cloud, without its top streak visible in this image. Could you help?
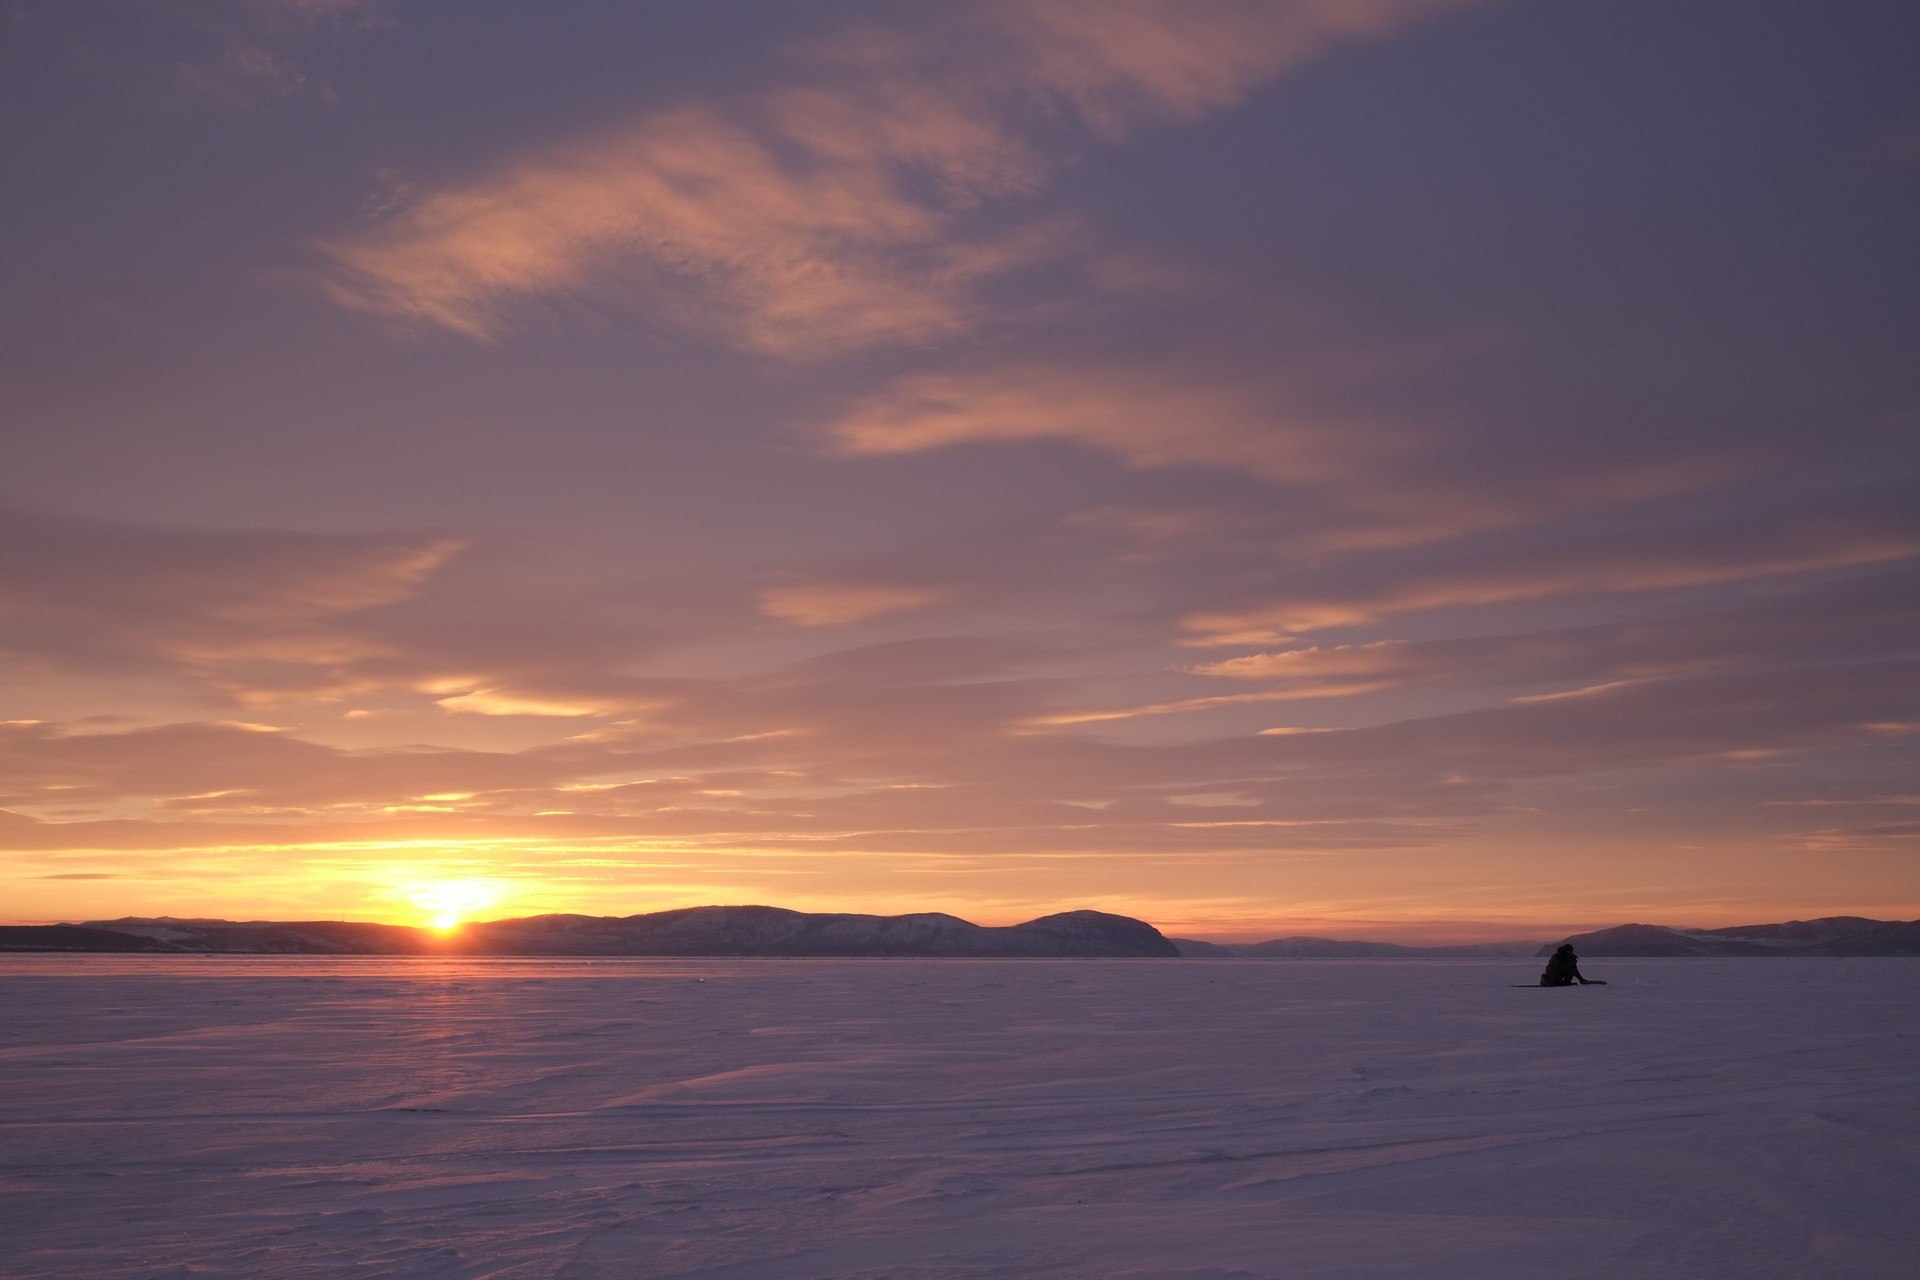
[326,107,1021,355]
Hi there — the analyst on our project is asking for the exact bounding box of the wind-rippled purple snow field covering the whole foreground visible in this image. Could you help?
[0,956,1920,1280]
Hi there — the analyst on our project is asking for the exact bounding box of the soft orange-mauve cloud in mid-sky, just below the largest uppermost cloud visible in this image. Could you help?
[820,347,1740,572]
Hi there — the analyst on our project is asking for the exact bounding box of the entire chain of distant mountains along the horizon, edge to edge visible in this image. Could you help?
[0,906,1920,960]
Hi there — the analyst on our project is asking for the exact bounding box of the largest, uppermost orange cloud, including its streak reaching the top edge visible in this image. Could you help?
[323,0,1461,359]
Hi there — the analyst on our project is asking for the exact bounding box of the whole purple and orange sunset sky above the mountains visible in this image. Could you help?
[0,0,1920,940]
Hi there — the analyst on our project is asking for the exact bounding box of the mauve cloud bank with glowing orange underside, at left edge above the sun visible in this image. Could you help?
[0,509,755,718]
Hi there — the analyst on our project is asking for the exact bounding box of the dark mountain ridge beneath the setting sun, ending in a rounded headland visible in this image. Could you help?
[0,906,1179,958]
